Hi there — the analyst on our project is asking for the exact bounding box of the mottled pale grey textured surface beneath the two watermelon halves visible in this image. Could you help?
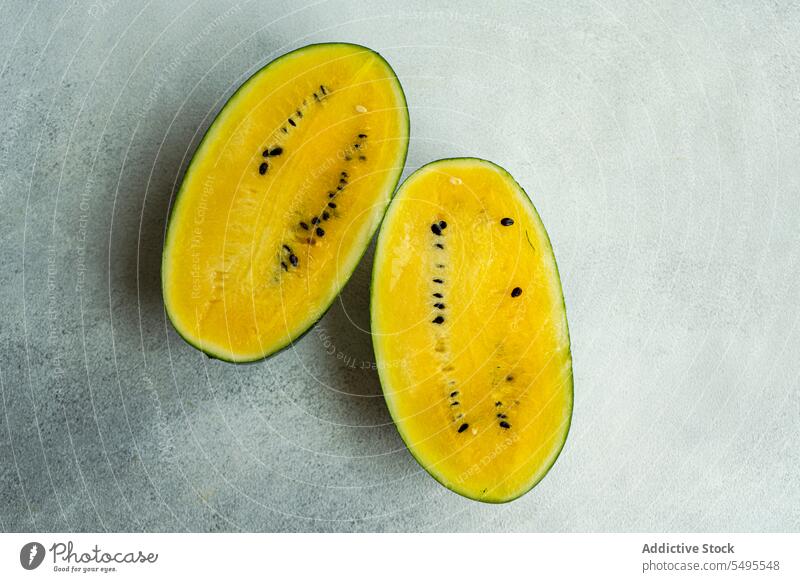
[0,0,800,531]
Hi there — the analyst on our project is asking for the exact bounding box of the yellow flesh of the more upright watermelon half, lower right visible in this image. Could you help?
[372,159,572,502]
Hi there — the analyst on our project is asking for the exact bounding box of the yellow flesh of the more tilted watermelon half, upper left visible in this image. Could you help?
[162,44,408,361]
